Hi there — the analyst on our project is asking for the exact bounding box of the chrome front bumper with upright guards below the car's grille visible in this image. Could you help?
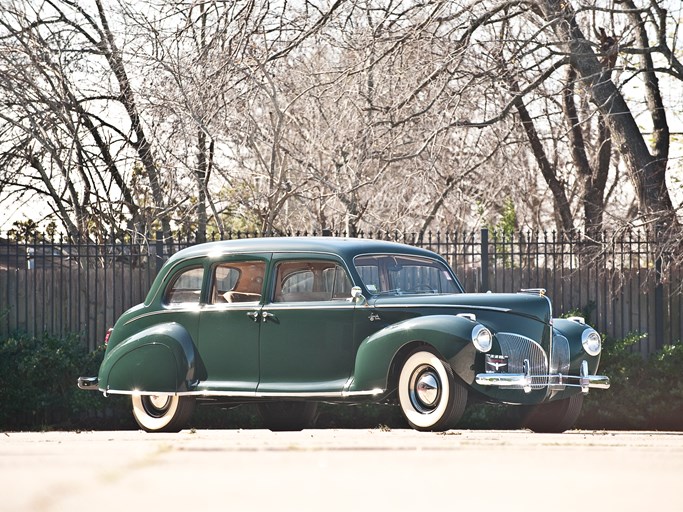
[475,359,610,393]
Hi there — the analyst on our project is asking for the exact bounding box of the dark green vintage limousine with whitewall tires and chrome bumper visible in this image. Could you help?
[78,237,609,432]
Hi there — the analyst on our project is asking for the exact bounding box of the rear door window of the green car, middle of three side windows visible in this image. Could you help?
[211,260,266,304]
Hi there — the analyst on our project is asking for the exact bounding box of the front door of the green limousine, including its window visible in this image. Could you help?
[258,254,356,395]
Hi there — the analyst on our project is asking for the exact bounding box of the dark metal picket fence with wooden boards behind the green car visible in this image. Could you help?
[0,229,683,355]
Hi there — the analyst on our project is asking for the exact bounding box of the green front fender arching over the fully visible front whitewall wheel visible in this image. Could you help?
[349,315,477,392]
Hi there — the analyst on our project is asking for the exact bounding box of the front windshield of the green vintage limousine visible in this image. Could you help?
[354,254,462,295]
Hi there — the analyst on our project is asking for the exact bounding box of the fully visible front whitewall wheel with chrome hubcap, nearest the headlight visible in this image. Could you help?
[398,349,467,432]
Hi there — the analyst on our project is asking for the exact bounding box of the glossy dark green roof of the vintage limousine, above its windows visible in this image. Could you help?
[166,236,438,261]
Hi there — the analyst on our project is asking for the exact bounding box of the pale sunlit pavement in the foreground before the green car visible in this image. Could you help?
[0,430,683,512]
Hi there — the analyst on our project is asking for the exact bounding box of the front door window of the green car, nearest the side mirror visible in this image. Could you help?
[273,261,353,302]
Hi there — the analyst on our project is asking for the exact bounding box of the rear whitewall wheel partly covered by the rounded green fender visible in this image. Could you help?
[132,395,195,432]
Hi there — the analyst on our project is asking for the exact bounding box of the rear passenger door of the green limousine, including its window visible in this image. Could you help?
[198,254,270,395]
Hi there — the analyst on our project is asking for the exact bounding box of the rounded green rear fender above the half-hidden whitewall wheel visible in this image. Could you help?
[99,322,196,393]
